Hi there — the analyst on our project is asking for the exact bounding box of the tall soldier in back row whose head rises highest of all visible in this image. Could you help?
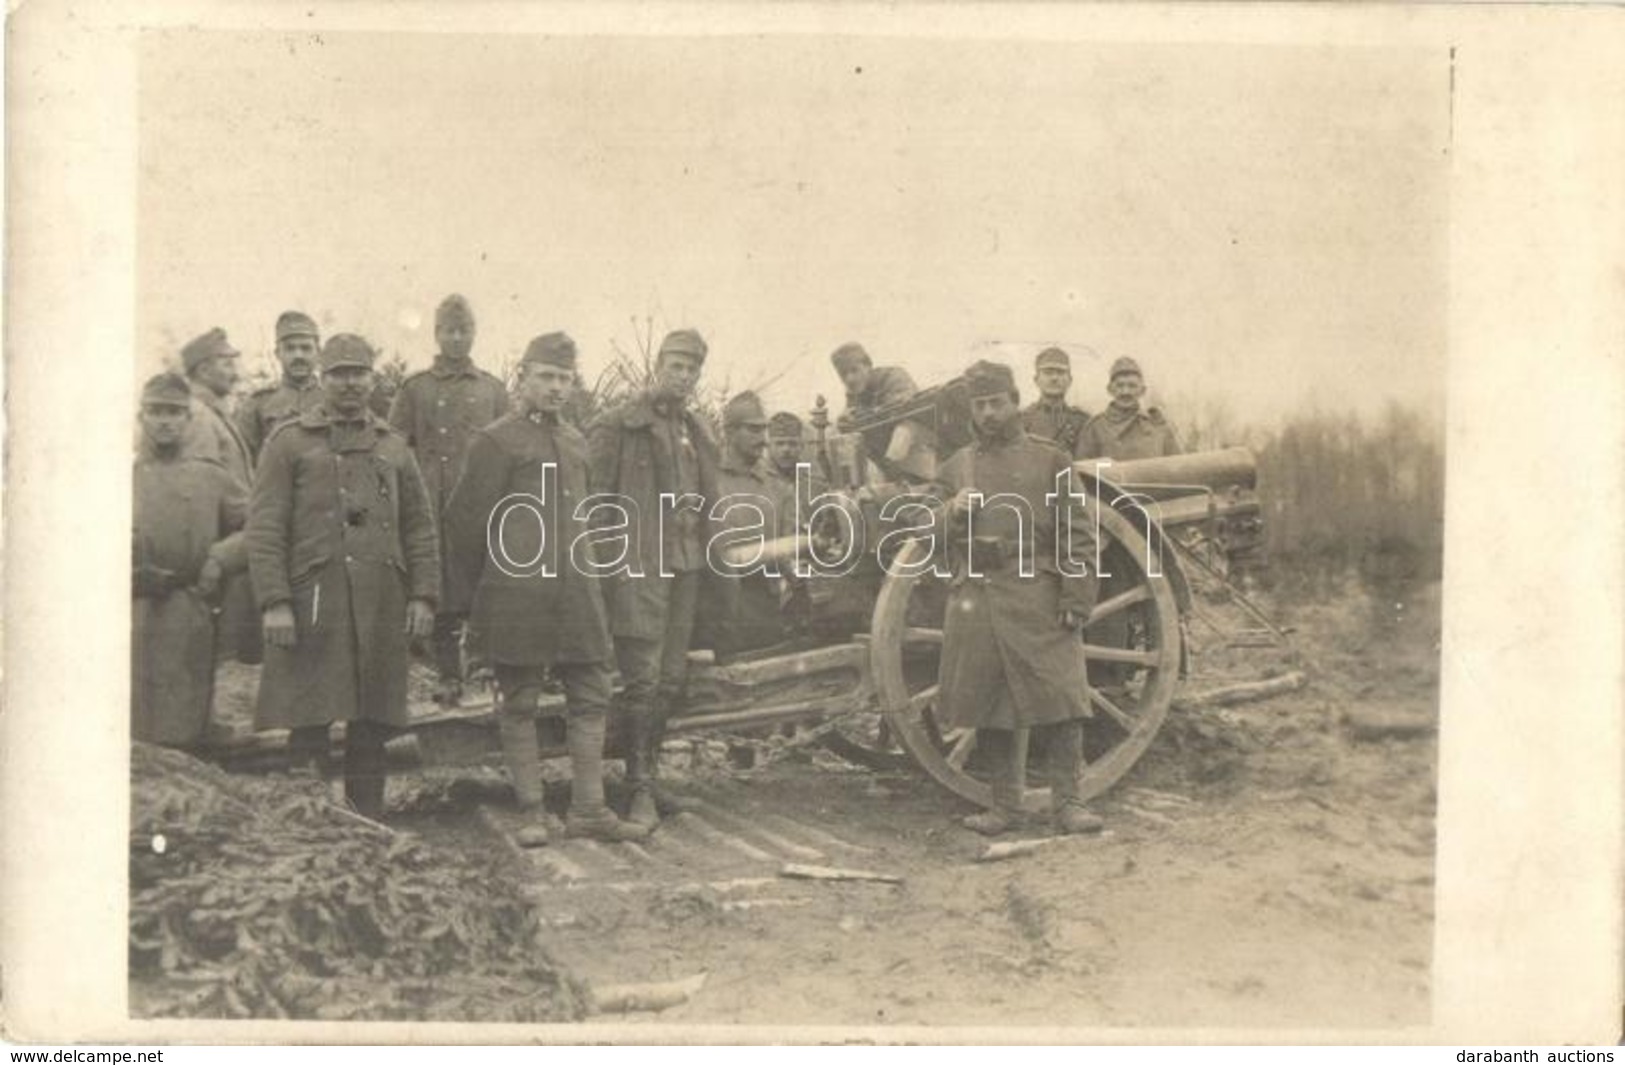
[390,293,509,706]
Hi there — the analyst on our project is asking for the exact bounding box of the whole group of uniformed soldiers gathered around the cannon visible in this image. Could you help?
[132,296,1178,841]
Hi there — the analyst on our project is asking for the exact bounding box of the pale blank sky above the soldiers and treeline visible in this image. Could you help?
[137,31,1450,419]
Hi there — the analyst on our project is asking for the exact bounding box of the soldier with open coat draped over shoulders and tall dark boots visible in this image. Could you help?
[587,328,718,824]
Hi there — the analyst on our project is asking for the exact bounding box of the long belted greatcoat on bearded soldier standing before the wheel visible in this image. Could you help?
[941,428,1095,728]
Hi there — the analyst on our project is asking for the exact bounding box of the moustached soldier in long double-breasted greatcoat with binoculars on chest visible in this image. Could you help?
[247,333,440,818]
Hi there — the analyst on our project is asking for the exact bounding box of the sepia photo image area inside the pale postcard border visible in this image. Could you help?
[8,5,1619,1042]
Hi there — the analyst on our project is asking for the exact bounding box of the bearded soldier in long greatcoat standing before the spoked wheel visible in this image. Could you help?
[939,363,1100,834]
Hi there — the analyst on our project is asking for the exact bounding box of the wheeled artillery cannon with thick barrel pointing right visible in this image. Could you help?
[349,375,1259,810]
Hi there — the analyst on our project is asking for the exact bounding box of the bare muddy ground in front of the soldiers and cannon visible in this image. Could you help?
[186,587,1438,1028]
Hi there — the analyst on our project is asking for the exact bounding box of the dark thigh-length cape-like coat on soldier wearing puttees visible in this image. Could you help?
[445,413,613,667]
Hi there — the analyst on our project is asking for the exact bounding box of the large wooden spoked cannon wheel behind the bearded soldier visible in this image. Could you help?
[869,507,1181,810]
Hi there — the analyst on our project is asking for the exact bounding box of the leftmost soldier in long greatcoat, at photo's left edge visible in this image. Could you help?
[130,374,249,746]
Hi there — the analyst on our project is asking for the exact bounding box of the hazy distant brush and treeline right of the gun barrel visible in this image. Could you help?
[1170,403,1445,592]
